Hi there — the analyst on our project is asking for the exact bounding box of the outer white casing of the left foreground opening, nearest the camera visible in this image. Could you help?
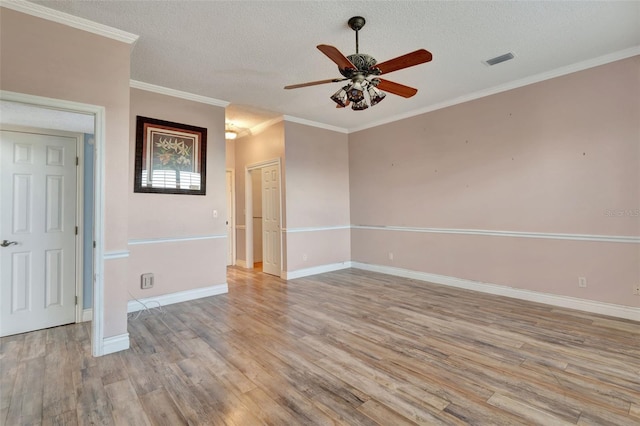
[0,90,106,356]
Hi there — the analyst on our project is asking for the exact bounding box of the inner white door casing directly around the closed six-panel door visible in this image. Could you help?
[0,125,84,323]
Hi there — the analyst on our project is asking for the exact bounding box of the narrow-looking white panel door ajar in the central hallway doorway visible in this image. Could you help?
[262,165,280,276]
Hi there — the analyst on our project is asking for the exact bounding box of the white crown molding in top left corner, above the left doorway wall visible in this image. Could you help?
[0,0,139,46]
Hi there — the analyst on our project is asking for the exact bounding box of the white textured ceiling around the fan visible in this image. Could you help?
[18,0,640,131]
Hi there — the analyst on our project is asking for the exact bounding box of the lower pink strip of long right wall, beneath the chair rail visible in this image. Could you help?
[351,229,639,306]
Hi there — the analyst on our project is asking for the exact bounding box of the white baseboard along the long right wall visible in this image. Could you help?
[352,262,640,321]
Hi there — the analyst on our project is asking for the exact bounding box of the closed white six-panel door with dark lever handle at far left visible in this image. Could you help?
[0,130,77,336]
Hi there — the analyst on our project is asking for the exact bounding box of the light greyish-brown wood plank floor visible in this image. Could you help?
[0,268,640,426]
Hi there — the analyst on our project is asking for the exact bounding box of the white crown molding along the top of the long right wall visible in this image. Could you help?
[348,45,640,133]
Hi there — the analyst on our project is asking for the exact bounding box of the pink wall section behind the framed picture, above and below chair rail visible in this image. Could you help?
[127,89,227,297]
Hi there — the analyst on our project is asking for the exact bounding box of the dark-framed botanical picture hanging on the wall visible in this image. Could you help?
[133,116,207,195]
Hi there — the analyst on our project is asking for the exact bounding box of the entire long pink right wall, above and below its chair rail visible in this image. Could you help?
[349,57,640,306]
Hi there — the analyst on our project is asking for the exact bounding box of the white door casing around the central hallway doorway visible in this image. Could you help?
[244,158,283,278]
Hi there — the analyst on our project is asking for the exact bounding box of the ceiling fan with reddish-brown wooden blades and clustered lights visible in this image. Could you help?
[285,16,433,111]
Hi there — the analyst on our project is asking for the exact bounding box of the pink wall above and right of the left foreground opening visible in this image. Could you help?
[0,8,131,337]
